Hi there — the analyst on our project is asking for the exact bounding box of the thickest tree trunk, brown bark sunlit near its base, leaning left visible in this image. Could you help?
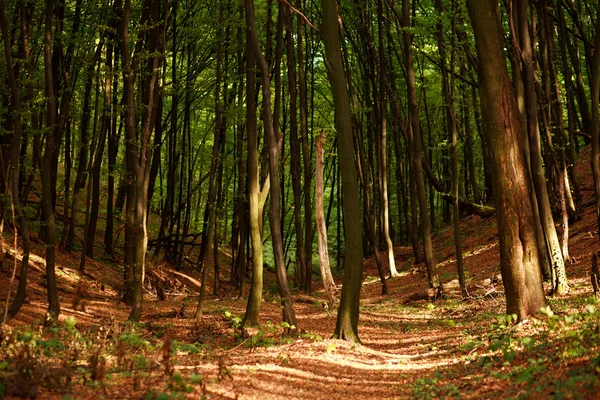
[467,0,546,320]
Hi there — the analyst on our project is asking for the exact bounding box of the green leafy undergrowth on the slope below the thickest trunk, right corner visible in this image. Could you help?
[411,298,600,399]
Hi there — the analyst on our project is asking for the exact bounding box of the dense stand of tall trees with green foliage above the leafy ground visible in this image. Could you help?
[0,0,600,396]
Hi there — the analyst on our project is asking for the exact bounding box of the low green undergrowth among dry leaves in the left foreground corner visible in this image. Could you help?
[0,317,205,399]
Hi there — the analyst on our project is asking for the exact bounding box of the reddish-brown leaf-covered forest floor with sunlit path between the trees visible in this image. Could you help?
[0,149,600,400]
